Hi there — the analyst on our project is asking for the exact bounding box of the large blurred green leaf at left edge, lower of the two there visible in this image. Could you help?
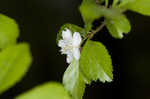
[0,43,32,93]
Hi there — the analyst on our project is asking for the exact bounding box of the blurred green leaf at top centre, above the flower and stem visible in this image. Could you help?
[79,0,122,31]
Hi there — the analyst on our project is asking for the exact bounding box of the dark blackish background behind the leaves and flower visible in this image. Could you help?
[0,0,150,99]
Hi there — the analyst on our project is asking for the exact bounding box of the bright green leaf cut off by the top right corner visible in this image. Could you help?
[120,0,150,16]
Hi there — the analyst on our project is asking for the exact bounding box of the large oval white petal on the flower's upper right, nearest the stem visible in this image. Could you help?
[73,32,82,47]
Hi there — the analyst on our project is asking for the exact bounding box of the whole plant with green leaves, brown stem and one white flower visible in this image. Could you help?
[0,0,150,99]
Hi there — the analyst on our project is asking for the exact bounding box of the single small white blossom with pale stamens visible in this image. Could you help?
[58,29,82,63]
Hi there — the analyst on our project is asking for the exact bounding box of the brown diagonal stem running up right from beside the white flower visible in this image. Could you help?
[81,22,105,45]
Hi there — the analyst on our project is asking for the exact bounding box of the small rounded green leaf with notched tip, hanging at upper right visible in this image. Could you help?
[105,15,131,39]
